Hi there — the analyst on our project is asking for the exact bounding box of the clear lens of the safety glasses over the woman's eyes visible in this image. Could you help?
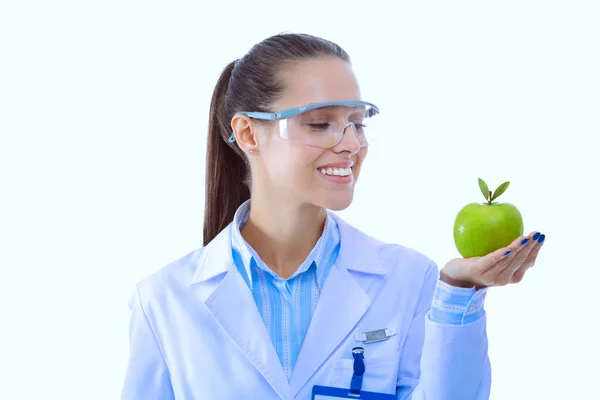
[279,106,376,149]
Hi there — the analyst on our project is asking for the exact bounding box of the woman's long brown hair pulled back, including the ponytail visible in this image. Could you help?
[203,33,350,246]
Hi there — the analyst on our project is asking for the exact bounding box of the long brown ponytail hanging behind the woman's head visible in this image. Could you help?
[203,61,250,246]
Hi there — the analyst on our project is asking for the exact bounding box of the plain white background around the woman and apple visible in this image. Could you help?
[0,0,600,400]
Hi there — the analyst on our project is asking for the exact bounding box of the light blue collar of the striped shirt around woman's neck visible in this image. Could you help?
[231,200,340,289]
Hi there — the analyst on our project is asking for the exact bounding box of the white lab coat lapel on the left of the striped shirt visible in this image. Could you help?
[188,224,292,399]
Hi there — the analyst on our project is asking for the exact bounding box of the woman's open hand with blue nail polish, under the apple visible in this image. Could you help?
[440,232,546,289]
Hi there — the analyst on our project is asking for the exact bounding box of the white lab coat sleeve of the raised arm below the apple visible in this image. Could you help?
[396,264,491,400]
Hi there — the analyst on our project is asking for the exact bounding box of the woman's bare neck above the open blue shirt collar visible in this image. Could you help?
[241,196,327,279]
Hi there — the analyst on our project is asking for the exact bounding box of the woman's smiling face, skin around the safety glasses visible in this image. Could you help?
[251,58,367,210]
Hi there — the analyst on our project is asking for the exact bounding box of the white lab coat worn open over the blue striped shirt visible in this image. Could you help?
[122,213,490,400]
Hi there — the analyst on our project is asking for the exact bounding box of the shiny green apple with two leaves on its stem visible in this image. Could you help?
[454,178,523,258]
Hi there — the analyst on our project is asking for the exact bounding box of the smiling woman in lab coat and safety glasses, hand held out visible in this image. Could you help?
[122,34,544,400]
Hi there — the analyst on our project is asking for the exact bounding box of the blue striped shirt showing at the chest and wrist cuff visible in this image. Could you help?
[231,200,486,379]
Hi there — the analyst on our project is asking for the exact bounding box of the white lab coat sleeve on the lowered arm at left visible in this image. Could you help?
[121,286,175,400]
